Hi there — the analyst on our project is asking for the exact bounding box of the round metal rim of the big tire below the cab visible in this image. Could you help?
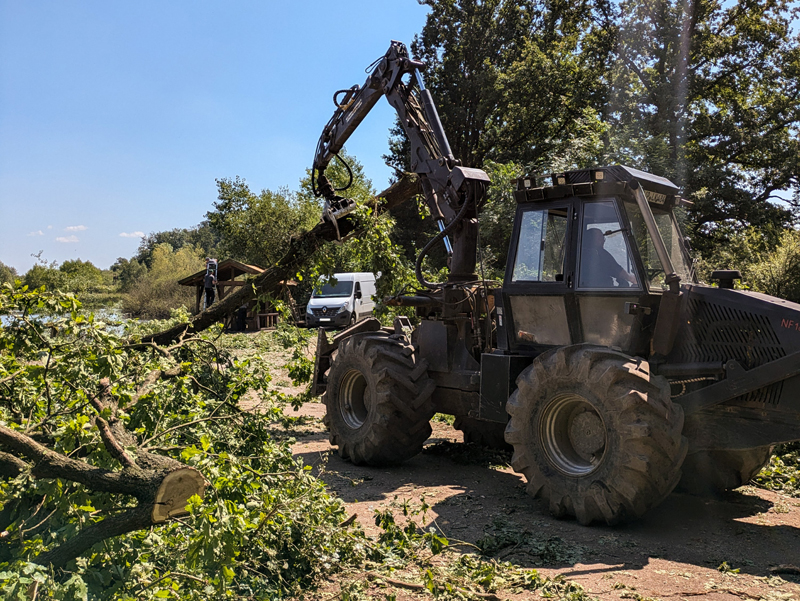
[539,393,608,476]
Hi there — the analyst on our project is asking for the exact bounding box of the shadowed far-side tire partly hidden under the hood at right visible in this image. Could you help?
[678,446,772,496]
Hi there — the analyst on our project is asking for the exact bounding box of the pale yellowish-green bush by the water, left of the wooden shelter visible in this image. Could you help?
[122,244,203,319]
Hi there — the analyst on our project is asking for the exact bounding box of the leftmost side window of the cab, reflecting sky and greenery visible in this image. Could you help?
[511,207,567,282]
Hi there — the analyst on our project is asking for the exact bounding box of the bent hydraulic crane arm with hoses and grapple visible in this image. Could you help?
[312,41,489,285]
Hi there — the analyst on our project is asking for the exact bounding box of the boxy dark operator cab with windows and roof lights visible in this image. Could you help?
[498,166,692,356]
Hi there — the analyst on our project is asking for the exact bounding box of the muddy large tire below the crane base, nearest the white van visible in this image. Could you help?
[324,332,436,465]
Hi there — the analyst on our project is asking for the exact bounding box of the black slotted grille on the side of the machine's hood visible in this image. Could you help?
[674,296,786,405]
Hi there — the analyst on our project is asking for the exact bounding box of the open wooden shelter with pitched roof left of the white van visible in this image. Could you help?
[178,259,297,332]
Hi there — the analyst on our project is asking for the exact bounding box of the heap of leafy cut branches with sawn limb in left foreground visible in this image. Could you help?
[0,285,359,599]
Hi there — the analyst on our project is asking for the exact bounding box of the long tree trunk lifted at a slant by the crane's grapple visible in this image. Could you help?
[142,174,421,345]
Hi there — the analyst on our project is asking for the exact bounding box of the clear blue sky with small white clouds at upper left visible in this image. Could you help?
[0,0,427,273]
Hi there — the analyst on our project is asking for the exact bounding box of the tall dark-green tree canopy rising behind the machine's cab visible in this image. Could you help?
[396,0,800,252]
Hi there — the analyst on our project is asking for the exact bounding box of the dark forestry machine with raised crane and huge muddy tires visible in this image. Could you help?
[312,42,800,524]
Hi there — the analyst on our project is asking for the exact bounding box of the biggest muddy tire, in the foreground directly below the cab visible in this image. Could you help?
[505,345,688,525]
